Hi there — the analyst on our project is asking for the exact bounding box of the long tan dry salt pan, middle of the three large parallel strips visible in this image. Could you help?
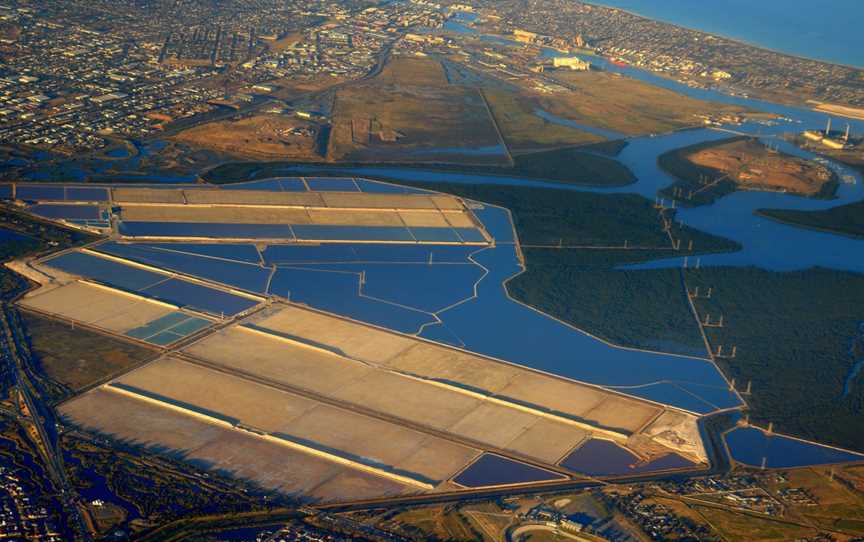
[187,323,600,464]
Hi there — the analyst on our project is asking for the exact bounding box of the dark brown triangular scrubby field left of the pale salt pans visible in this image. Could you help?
[22,312,157,400]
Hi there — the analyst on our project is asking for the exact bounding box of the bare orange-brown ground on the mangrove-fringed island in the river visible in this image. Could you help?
[687,139,832,196]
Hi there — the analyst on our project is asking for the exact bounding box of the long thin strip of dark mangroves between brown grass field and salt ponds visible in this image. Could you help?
[202,143,636,186]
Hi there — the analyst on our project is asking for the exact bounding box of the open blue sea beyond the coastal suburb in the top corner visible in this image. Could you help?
[592,0,864,67]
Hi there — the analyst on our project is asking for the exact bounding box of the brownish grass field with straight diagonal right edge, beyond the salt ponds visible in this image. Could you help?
[327,57,509,164]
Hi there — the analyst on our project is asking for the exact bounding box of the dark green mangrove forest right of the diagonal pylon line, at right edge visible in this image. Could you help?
[685,268,864,451]
